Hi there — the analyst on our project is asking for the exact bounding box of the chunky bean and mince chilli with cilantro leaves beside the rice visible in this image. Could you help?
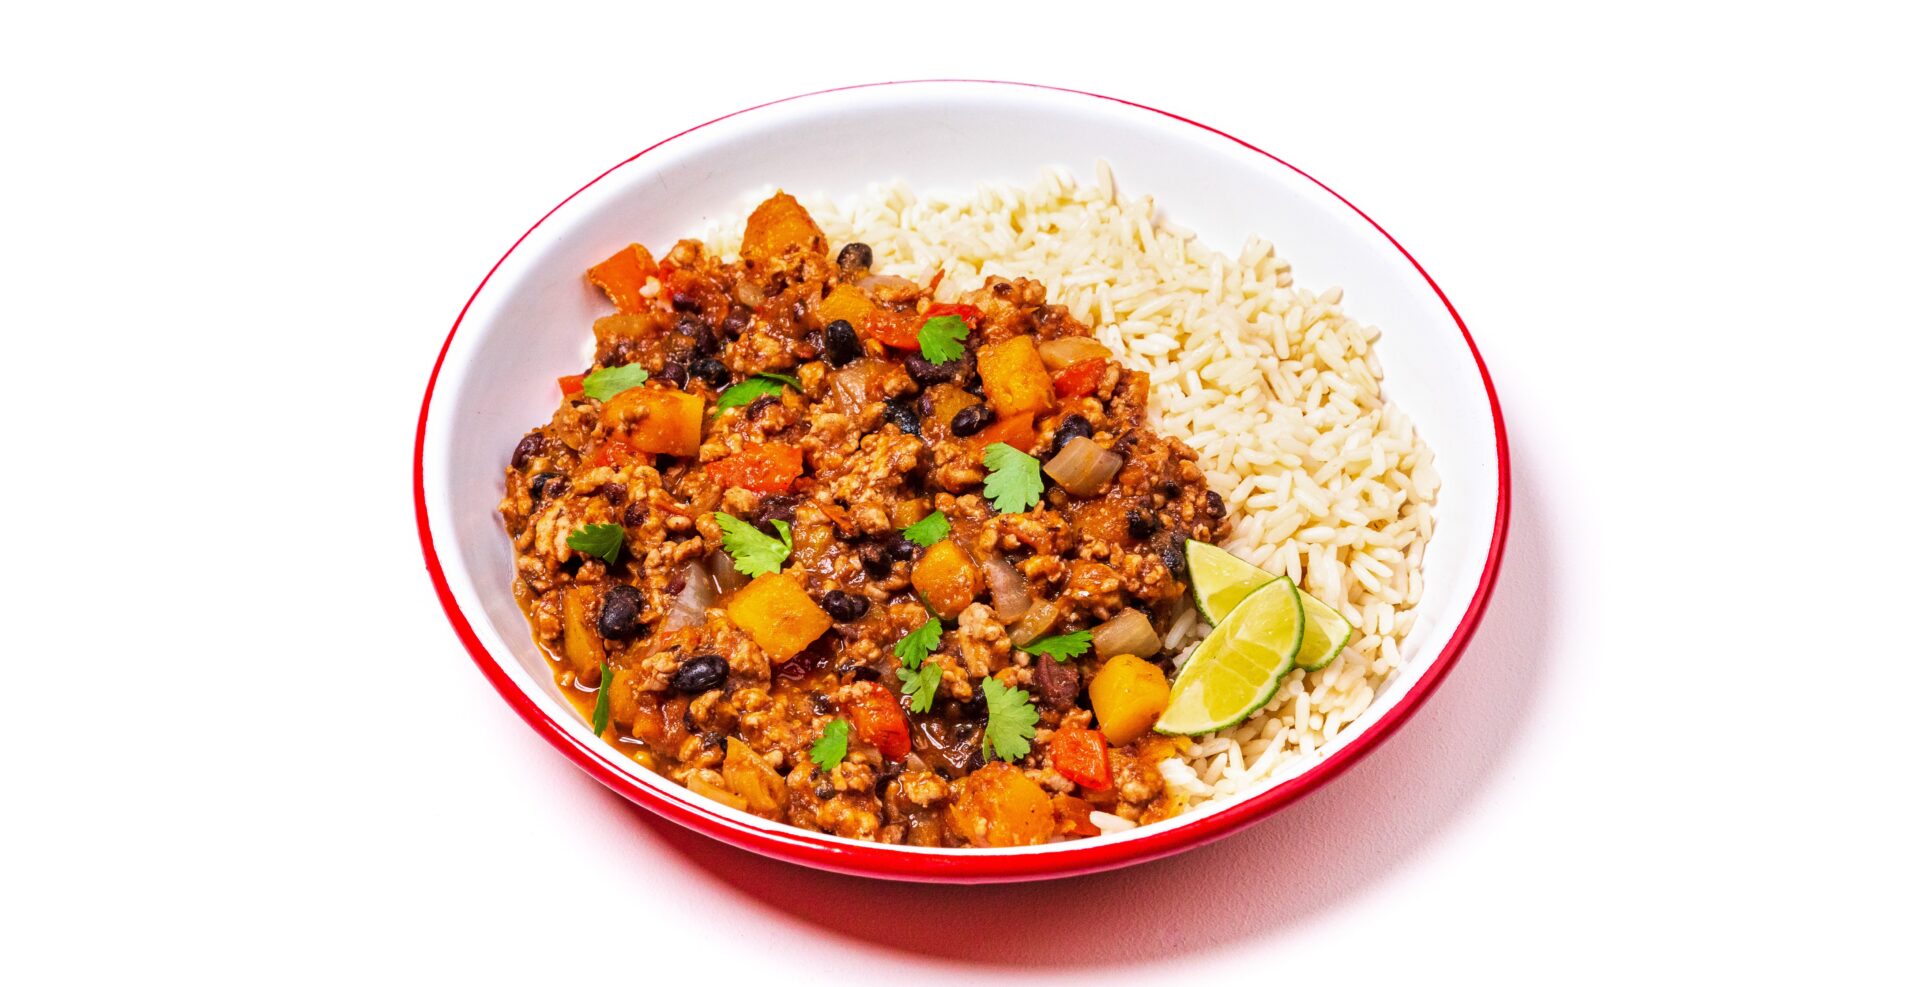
[501,194,1225,847]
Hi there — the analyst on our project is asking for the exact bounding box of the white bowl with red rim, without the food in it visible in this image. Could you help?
[413,81,1509,881]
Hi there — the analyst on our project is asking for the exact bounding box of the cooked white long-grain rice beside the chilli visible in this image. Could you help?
[707,163,1440,814]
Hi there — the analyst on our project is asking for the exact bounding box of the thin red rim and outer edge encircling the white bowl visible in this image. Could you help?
[413,79,1511,883]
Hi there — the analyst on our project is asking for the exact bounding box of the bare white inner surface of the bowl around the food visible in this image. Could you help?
[424,83,1498,853]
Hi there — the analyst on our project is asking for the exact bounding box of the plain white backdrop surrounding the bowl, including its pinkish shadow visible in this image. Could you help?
[0,2,1920,983]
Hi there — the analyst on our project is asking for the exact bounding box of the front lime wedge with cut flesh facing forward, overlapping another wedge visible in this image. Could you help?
[1154,578,1308,734]
